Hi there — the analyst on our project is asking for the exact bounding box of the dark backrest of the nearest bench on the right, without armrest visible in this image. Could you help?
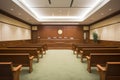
[105,62,120,80]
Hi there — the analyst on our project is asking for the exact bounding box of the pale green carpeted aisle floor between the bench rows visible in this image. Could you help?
[20,50,99,80]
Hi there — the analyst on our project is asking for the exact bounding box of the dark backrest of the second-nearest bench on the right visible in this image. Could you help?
[90,53,120,66]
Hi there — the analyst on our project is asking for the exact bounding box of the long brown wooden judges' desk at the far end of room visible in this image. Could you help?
[39,39,80,49]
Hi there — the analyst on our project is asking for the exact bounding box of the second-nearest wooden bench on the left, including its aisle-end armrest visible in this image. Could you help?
[0,53,33,72]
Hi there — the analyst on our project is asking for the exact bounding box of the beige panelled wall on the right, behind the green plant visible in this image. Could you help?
[90,15,120,41]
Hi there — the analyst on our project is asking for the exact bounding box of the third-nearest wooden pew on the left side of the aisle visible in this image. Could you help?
[0,48,39,62]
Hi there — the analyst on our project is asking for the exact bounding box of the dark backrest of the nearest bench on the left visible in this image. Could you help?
[0,62,13,80]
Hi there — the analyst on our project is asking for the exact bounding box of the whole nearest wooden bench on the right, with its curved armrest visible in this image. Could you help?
[97,62,120,80]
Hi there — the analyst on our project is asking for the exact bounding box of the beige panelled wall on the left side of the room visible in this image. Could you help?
[0,14,31,41]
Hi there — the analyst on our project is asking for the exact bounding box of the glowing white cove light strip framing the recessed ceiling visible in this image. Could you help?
[12,0,110,22]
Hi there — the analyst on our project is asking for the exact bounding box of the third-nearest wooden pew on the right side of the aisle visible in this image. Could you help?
[80,48,120,62]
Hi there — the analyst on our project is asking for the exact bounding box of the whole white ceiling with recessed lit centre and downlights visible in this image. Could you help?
[0,0,120,25]
